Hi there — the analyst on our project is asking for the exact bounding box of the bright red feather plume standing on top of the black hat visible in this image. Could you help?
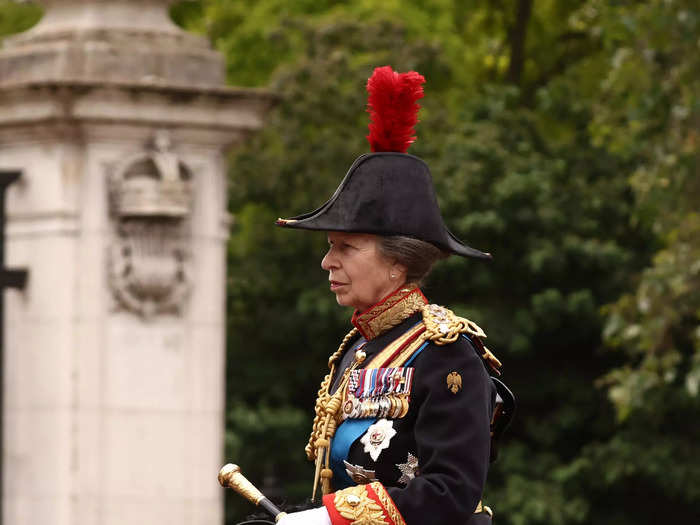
[367,66,425,153]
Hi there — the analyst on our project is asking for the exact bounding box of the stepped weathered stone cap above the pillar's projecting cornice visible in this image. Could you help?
[0,0,224,86]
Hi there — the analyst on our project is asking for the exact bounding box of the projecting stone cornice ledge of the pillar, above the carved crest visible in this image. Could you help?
[0,81,277,131]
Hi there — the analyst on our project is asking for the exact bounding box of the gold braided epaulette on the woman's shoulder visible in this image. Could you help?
[423,304,501,372]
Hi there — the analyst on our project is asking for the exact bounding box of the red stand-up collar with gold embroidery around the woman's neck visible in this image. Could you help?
[352,284,428,341]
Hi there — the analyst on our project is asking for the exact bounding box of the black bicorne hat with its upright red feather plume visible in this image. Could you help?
[277,66,491,259]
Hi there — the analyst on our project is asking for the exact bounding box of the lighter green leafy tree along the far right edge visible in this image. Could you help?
[592,0,700,417]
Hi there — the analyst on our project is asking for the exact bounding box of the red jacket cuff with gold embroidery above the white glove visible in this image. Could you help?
[323,481,406,525]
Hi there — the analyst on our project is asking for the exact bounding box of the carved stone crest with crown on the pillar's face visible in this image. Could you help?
[109,132,192,318]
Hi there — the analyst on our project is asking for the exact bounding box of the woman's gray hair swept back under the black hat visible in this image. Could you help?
[379,235,450,284]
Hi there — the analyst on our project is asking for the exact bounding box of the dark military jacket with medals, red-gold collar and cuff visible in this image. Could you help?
[312,287,496,525]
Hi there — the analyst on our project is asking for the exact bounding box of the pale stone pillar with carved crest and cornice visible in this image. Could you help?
[0,0,271,525]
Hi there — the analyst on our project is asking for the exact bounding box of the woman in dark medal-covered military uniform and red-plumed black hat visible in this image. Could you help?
[270,66,500,525]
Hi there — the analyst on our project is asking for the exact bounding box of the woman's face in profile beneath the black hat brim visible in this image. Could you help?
[321,232,406,311]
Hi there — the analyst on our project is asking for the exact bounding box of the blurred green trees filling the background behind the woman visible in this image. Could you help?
[0,0,700,525]
